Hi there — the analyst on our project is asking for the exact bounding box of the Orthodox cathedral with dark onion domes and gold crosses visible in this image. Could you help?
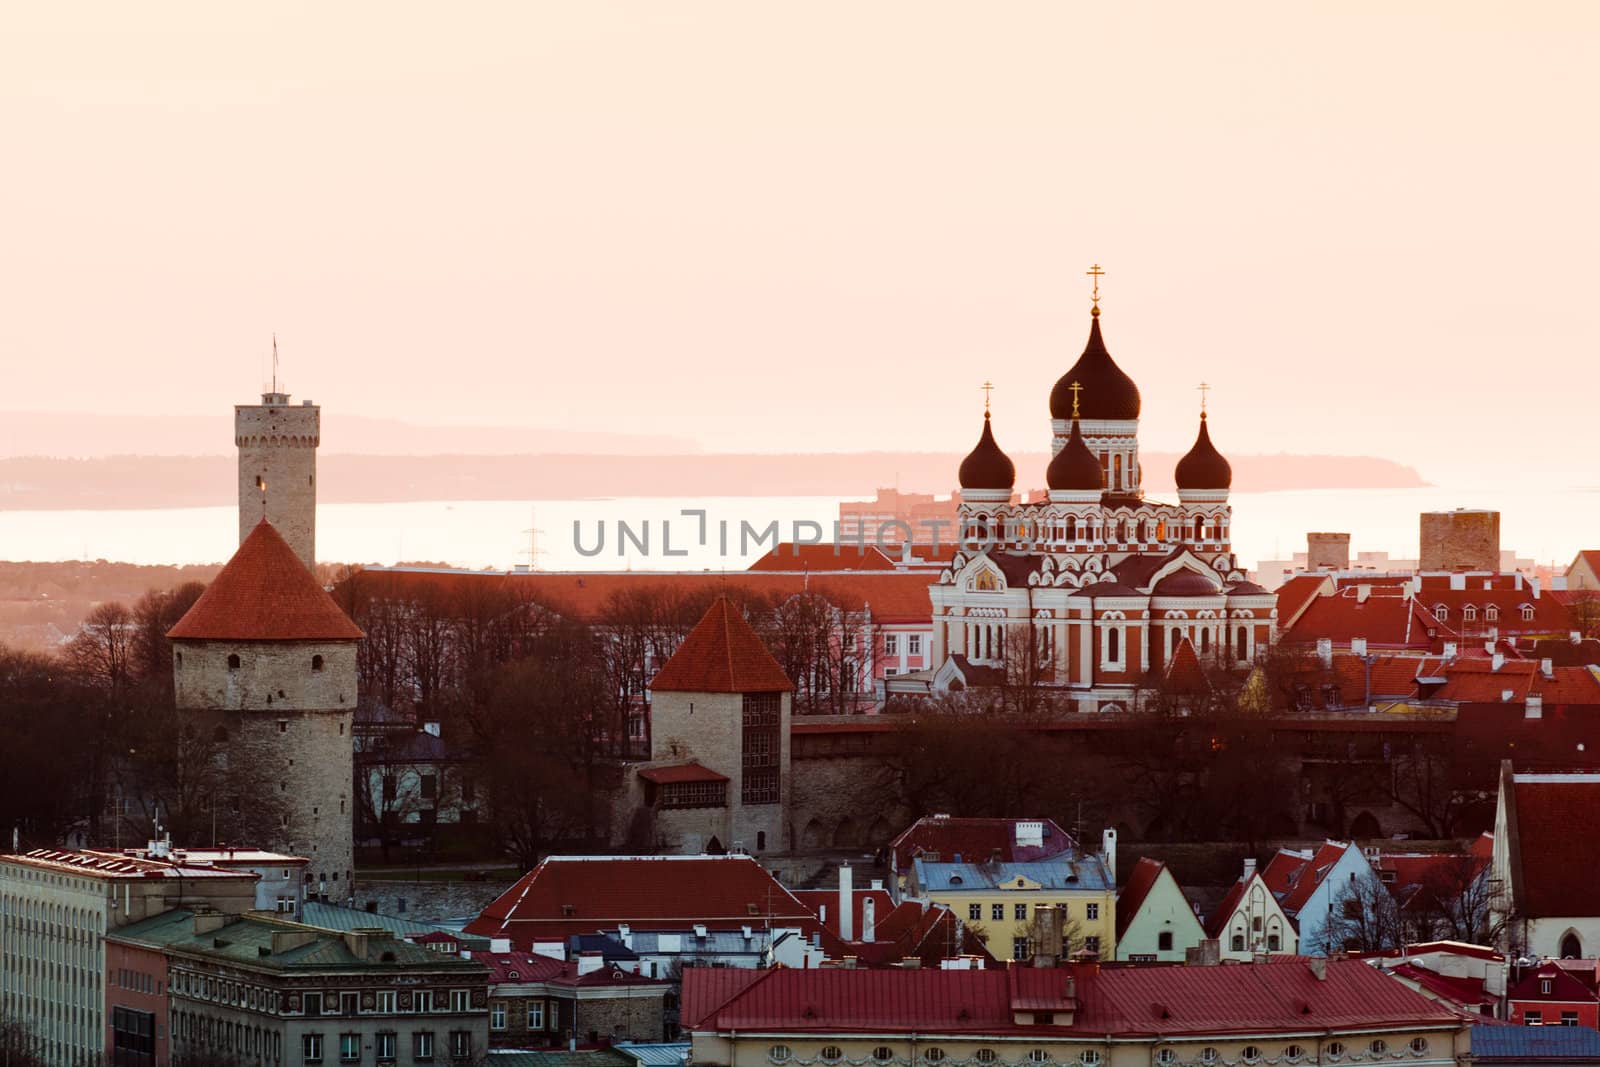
[930,278,1277,712]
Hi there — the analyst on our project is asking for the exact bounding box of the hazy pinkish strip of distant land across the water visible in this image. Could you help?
[0,451,1427,510]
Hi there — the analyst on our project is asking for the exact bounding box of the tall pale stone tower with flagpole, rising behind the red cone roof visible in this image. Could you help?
[234,379,322,569]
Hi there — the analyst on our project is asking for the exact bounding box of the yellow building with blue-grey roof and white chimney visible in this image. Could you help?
[906,830,1117,960]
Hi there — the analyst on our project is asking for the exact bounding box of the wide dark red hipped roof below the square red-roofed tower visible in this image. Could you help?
[466,856,819,949]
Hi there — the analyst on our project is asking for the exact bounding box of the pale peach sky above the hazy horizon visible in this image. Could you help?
[0,0,1600,478]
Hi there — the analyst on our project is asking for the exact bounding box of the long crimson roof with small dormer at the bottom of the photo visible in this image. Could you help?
[683,960,1458,1037]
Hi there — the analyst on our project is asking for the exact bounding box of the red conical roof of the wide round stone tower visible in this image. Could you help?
[166,518,363,641]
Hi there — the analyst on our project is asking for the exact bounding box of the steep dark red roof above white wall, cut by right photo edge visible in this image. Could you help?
[1509,774,1600,918]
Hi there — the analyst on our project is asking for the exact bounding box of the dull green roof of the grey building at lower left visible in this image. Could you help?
[107,909,486,973]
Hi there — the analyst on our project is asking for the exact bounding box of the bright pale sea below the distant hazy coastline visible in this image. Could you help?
[0,482,1600,571]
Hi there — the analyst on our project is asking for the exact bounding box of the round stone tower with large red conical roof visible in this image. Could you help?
[166,520,363,899]
